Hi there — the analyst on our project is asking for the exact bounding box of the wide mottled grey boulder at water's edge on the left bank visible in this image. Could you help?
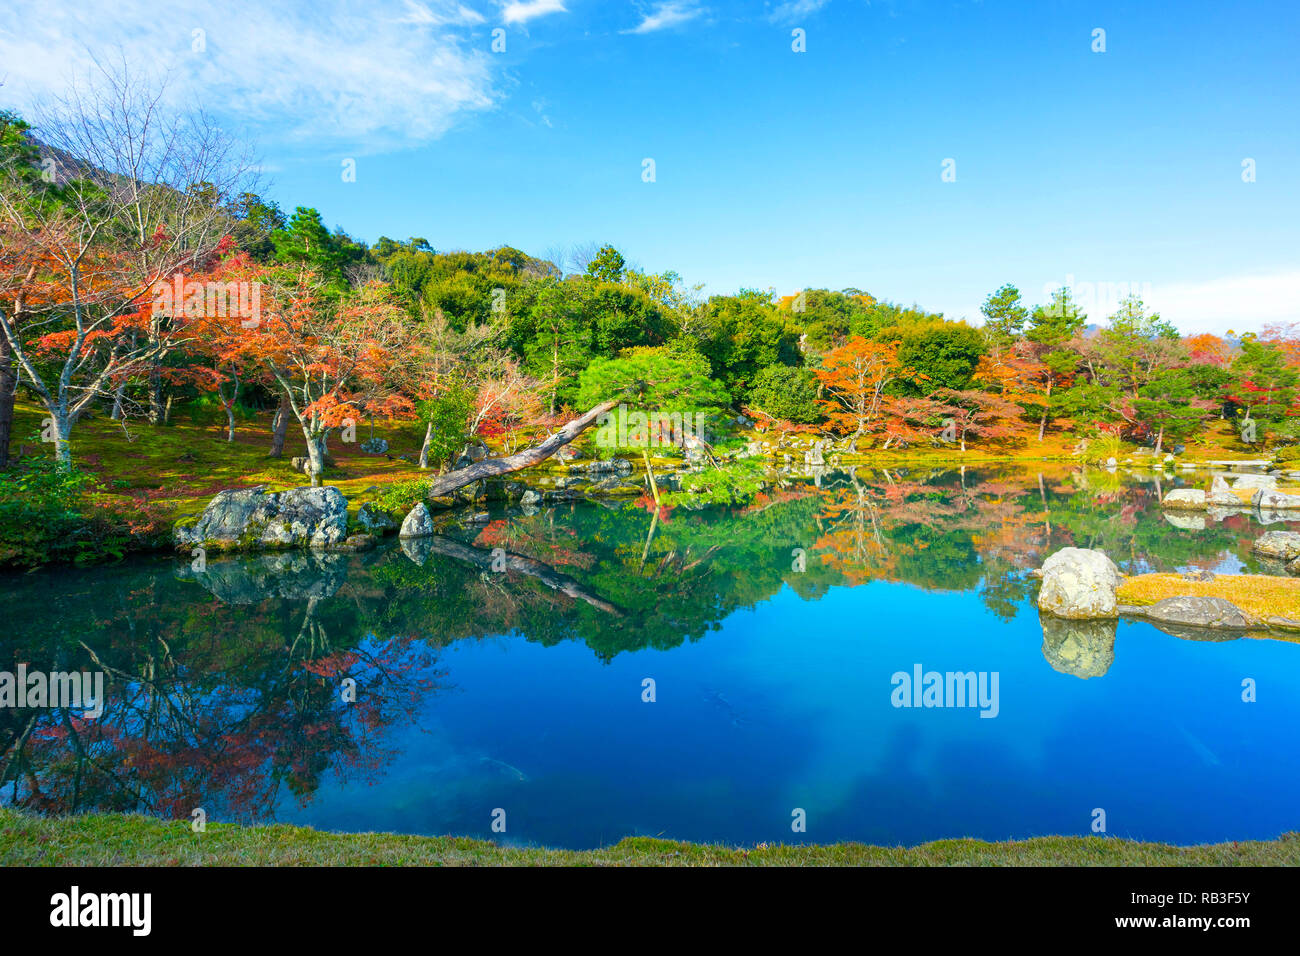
[173,485,347,550]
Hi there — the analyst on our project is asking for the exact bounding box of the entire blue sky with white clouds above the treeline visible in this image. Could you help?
[0,0,1300,332]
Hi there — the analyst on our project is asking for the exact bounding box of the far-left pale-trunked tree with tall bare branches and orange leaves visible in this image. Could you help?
[0,62,252,468]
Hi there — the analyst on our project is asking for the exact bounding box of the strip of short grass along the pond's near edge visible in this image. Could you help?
[0,810,1300,866]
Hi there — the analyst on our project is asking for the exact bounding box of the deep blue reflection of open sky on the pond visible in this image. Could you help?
[282,583,1300,847]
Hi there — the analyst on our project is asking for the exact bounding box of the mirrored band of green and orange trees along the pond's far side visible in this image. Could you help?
[0,467,1279,818]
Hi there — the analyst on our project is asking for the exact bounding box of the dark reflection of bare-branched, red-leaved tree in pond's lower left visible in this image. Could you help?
[0,559,436,819]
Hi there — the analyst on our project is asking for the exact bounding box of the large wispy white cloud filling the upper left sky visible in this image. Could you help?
[0,0,497,153]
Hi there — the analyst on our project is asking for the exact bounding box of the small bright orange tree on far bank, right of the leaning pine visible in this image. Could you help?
[813,336,915,450]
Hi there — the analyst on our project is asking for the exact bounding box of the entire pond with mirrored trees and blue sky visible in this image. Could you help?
[0,467,1300,848]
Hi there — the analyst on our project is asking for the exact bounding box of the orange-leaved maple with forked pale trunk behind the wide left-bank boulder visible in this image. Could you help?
[202,264,412,486]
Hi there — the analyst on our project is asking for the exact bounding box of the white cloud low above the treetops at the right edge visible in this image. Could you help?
[1147,269,1300,336]
